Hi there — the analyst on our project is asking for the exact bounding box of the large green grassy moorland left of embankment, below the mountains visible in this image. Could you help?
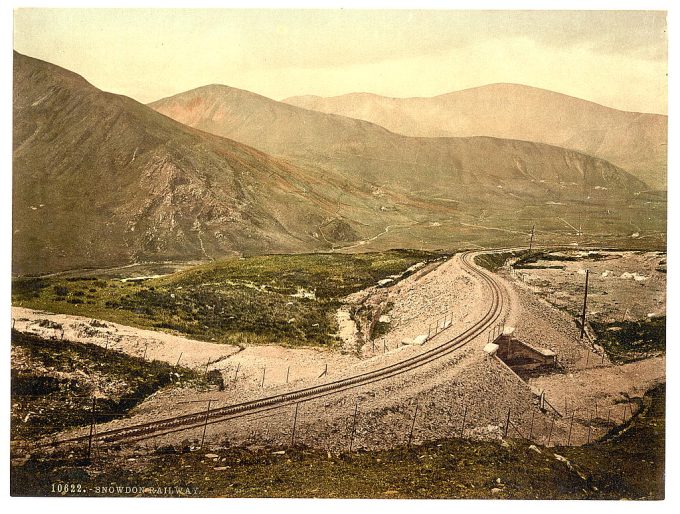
[12,250,442,347]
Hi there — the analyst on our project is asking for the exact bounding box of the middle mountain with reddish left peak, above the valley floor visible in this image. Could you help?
[150,85,646,199]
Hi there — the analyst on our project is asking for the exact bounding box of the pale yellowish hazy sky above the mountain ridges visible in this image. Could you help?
[14,9,667,114]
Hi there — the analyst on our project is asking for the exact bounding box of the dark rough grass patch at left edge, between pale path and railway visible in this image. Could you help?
[11,330,202,439]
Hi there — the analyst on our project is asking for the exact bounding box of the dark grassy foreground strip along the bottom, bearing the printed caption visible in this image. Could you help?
[11,385,665,499]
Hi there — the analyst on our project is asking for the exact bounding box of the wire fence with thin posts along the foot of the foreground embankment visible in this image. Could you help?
[13,384,641,462]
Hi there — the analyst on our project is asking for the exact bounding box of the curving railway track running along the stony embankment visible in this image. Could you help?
[43,252,503,446]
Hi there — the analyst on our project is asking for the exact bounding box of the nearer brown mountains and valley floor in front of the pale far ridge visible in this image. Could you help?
[12,52,665,275]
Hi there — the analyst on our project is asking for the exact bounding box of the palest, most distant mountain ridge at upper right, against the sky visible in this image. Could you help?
[283,84,668,189]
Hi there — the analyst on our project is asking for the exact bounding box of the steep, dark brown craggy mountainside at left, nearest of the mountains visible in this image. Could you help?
[13,53,366,274]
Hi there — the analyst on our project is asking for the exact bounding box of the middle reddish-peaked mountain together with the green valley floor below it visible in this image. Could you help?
[150,85,665,249]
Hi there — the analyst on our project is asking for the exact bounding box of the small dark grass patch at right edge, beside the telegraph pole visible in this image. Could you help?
[590,316,666,363]
